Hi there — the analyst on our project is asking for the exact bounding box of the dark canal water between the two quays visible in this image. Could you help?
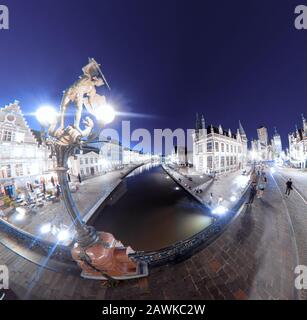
[89,164,213,251]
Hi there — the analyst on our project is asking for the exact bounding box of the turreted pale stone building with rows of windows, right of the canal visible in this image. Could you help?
[193,116,247,174]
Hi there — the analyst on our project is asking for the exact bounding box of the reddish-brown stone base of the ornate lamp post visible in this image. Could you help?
[72,232,148,280]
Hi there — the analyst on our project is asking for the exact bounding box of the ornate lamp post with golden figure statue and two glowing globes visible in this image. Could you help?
[37,59,148,280]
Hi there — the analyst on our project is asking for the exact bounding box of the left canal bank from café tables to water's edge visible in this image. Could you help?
[0,164,142,245]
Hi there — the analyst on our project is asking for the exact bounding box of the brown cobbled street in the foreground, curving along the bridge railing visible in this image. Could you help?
[0,168,307,300]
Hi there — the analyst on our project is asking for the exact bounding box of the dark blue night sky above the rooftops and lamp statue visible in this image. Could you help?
[0,0,307,148]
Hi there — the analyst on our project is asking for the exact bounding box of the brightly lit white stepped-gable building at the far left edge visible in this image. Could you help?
[0,101,55,196]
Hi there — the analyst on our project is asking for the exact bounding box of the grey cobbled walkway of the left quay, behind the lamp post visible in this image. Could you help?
[3,165,135,243]
